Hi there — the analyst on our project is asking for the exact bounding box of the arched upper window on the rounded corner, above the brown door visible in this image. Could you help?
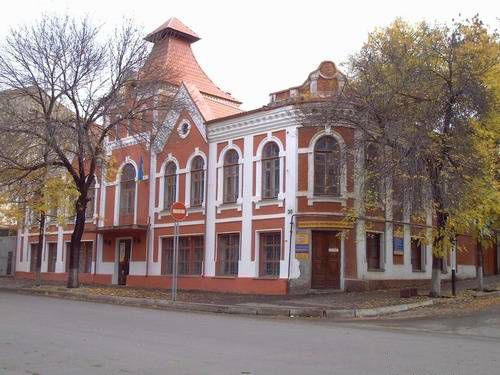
[314,136,341,196]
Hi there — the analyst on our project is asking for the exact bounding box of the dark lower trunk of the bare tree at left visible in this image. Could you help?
[67,194,87,288]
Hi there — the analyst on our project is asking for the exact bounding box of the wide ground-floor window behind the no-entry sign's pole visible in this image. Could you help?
[161,236,204,275]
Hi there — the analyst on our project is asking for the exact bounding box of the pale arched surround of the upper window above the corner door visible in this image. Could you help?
[307,126,347,206]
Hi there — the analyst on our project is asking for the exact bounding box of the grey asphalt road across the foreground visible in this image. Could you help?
[0,292,500,375]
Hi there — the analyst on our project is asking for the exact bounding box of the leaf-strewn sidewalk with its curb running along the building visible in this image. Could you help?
[0,275,500,319]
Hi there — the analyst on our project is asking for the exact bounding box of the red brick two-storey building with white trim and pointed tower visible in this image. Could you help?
[16,18,500,294]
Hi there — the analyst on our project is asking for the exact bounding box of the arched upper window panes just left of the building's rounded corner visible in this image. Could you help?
[262,142,280,199]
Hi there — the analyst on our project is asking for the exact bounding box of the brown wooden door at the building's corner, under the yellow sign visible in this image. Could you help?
[311,231,340,289]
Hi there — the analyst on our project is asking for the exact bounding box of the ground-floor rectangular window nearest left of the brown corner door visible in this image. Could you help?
[259,232,281,277]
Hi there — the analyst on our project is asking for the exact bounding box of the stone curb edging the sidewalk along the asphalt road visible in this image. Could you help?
[0,286,434,320]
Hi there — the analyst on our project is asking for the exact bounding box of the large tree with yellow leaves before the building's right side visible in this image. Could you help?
[301,17,500,296]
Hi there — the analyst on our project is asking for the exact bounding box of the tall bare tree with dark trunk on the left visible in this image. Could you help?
[0,16,177,288]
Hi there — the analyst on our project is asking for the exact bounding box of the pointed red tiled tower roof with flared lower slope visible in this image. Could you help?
[145,17,241,118]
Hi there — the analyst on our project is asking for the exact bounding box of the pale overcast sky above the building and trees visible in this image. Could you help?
[0,0,500,109]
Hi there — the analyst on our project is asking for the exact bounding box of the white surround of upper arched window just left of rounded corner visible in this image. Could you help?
[253,134,285,208]
